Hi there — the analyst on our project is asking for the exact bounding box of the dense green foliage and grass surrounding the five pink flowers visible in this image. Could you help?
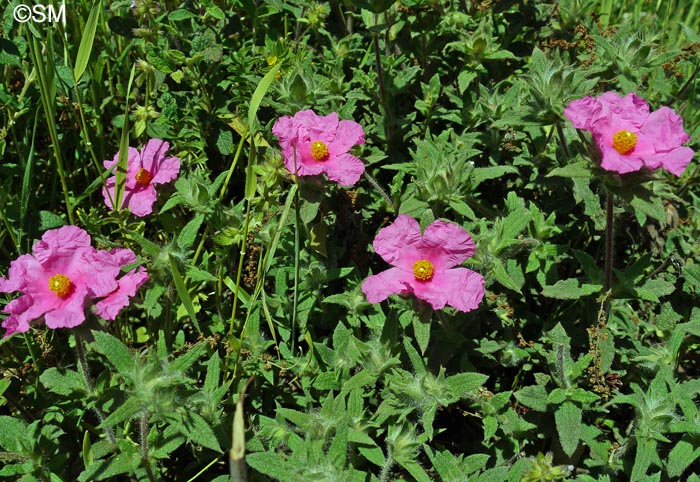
[0,0,700,482]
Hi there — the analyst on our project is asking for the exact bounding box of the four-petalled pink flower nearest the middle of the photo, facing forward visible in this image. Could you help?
[362,214,484,311]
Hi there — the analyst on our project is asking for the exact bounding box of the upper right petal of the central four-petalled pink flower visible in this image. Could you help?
[418,219,476,270]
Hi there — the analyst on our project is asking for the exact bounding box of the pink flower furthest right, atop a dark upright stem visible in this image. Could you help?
[564,92,693,176]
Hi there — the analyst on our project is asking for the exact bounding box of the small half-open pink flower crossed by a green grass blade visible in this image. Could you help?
[102,139,180,217]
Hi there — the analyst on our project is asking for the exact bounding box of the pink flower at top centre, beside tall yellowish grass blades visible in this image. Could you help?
[272,110,365,186]
